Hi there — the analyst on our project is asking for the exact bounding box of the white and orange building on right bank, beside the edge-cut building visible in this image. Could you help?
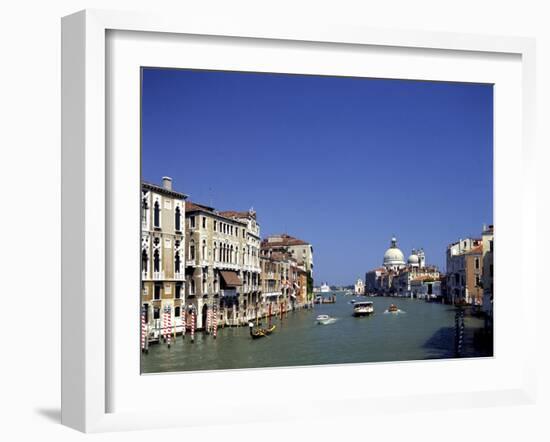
[446,238,483,305]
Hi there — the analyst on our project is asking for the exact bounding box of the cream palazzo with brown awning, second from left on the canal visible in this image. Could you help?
[185,202,260,329]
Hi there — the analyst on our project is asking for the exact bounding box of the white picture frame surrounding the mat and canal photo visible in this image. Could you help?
[62,10,536,432]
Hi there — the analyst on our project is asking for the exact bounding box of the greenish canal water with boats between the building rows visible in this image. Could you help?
[141,293,492,373]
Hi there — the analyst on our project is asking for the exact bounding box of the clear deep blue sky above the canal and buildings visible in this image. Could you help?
[142,69,493,284]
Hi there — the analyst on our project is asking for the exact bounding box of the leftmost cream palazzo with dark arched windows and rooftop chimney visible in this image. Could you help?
[141,177,187,338]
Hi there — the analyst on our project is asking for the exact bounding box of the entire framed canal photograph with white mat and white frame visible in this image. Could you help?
[62,11,536,432]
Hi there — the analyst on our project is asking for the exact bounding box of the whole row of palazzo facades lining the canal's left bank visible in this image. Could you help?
[141,177,313,339]
